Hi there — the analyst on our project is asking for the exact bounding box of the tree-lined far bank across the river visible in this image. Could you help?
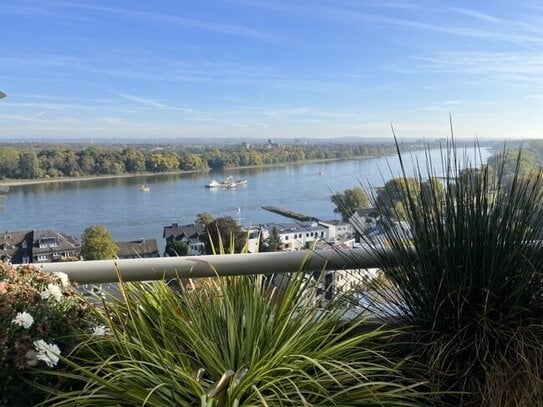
[0,143,412,185]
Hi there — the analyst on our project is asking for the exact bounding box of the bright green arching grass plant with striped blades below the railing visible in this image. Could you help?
[41,273,425,407]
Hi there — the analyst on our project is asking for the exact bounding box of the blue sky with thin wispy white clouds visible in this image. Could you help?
[0,0,543,139]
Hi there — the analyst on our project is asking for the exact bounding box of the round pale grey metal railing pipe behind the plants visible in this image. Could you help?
[39,248,382,284]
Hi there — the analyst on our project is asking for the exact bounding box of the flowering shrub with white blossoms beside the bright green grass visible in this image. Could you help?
[0,263,96,406]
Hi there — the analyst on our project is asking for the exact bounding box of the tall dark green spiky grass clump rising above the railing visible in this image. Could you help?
[370,142,543,406]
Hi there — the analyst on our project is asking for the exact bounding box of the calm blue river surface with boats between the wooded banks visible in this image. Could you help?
[0,149,490,251]
